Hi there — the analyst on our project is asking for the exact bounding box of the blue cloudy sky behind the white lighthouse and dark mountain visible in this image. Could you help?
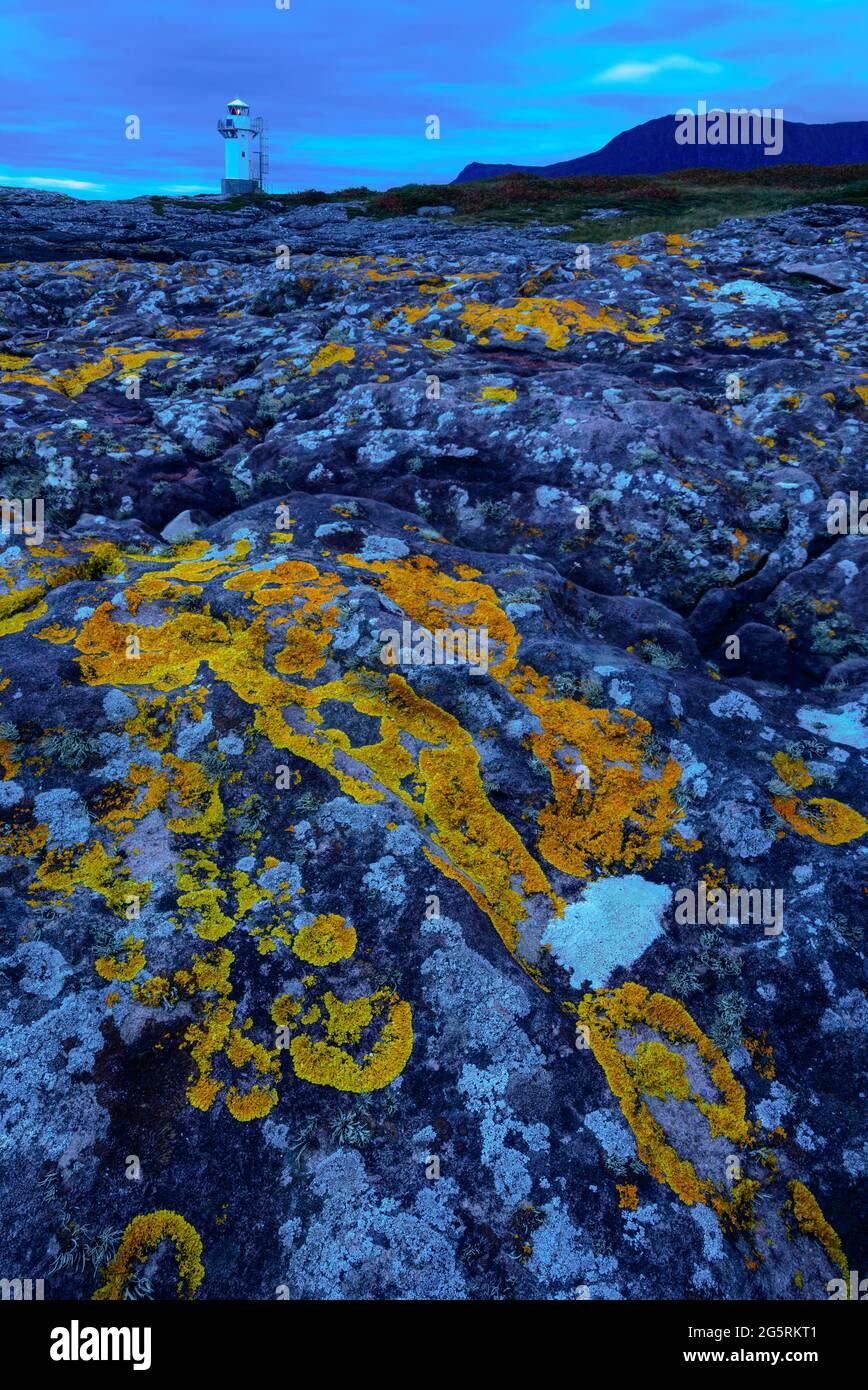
[0,0,868,197]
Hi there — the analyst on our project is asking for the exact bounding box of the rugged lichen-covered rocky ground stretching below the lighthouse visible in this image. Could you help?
[0,189,868,1300]
